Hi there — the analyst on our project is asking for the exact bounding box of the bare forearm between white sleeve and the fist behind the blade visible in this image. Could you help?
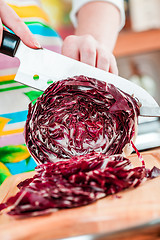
[75,1,120,51]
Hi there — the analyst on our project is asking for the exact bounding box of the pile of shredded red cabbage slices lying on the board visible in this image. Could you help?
[0,153,150,216]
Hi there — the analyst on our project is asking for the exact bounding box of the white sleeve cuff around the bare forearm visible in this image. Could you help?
[70,0,125,30]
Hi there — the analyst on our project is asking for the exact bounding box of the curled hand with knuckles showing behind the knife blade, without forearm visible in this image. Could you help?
[62,34,118,74]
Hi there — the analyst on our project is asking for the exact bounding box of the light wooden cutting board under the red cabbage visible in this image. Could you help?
[0,149,160,240]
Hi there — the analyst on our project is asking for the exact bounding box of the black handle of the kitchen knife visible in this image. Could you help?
[0,30,20,57]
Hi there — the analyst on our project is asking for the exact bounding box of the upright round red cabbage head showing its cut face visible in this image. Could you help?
[25,76,139,164]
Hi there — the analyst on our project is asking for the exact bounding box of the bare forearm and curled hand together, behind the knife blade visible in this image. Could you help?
[62,1,121,74]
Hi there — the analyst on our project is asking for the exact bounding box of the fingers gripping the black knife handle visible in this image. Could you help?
[0,0,41,48]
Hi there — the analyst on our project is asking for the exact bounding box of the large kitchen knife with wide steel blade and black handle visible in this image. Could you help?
[0,30,160,117]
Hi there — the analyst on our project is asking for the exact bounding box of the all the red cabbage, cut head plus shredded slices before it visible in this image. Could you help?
[0,76,160,216]
